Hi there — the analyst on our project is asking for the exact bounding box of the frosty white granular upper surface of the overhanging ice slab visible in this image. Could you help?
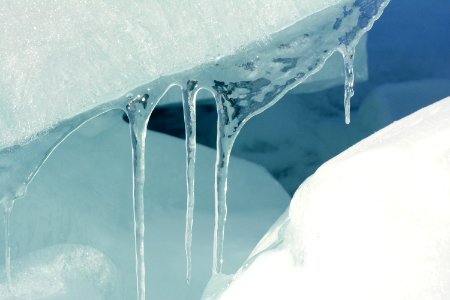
[0,0,344,146]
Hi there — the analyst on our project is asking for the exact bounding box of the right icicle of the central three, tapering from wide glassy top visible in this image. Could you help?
[212,94,236,274]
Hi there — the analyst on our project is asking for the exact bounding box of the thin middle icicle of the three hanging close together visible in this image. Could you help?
[183,80,197,284]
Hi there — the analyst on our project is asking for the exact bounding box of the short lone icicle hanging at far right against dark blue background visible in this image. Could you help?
[338,46,355,124]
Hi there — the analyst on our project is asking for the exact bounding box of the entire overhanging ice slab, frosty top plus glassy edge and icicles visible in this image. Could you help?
[0,0,389,300]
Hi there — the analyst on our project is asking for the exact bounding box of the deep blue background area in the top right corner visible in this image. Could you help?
[367,0,450,84]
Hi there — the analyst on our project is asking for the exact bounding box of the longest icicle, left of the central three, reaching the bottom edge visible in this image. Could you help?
[127,94,148,300]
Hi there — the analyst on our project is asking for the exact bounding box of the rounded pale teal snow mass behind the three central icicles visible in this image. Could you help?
[0,111,289,300]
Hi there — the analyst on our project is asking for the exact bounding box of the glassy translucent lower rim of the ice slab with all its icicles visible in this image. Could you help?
[0,0,389,300]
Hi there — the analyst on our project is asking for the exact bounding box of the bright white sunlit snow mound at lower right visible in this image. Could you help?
[212,98,450,300]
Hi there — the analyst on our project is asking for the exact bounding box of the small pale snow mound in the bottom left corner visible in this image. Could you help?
[0,245,120,300]
